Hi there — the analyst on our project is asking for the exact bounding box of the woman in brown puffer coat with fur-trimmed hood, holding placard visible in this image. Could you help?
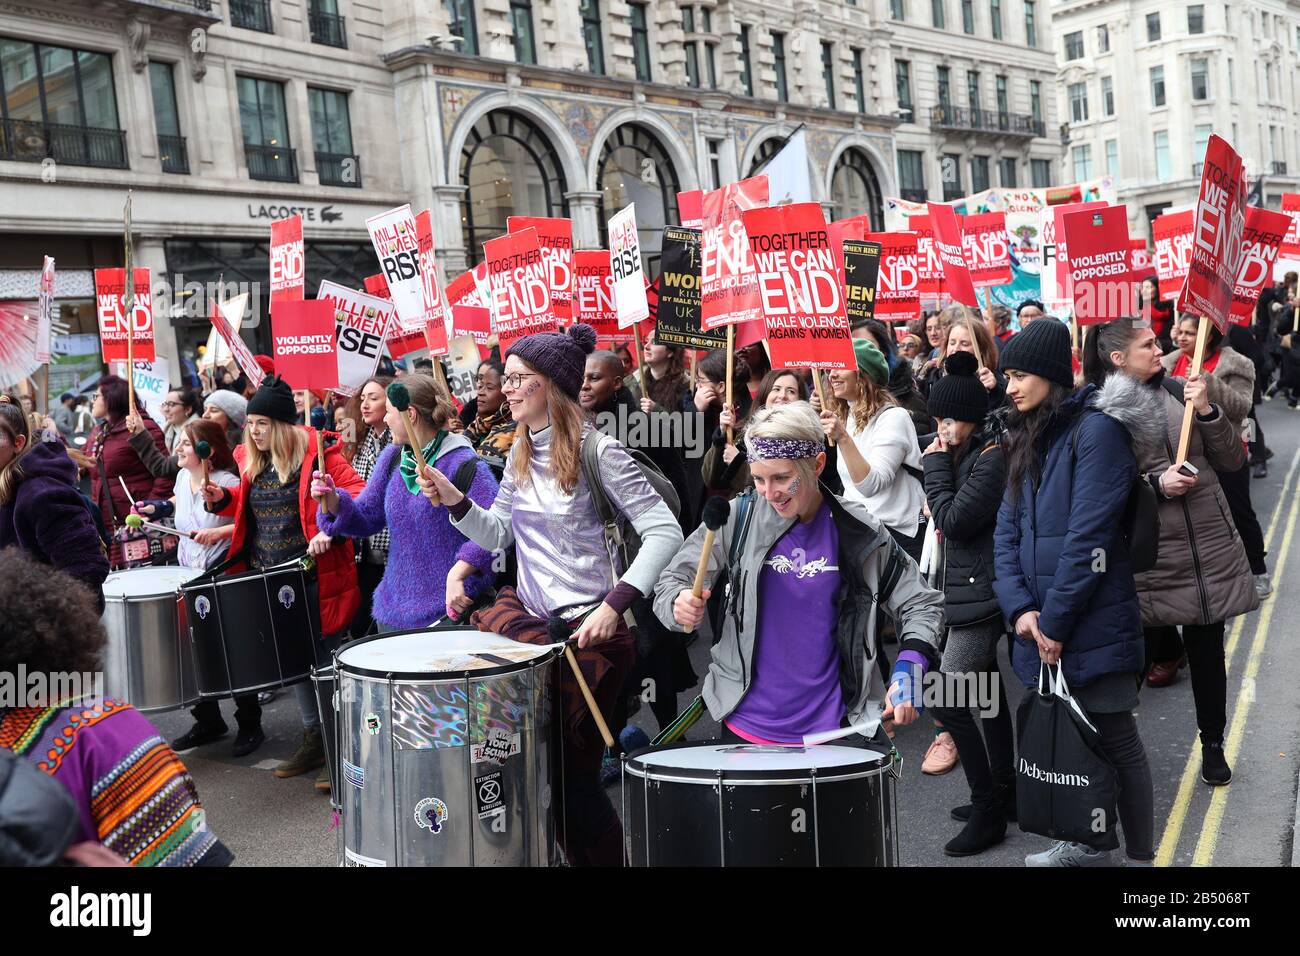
[1083,316,1260,786]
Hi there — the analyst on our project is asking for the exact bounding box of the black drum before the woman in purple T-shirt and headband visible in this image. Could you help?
[623,743,898,866]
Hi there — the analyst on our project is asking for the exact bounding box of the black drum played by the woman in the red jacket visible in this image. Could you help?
[181,559,320,697]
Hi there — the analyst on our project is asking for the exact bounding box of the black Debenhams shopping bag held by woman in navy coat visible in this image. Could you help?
[1015,665,1119,851]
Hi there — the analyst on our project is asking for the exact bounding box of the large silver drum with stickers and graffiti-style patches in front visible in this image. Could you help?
[335,628,562,866]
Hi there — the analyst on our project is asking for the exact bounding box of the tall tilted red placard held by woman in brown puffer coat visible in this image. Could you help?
[1178,137,1247,334]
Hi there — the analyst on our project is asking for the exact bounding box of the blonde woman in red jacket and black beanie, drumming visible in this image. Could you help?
[203,377,365,777]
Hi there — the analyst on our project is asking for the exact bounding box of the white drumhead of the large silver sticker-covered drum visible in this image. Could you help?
[338,630,553,680]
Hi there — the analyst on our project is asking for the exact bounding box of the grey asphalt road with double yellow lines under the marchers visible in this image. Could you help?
[155,401,1300,866]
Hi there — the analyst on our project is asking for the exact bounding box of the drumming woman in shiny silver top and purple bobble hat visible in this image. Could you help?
[419,324,681,866]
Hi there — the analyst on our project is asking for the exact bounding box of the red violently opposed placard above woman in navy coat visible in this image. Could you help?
[1061,206,1134,325]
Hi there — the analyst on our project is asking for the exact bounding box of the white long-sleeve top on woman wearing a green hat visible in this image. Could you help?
[837,405,924,537]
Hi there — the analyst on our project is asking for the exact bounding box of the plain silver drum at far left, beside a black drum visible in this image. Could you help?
[103,567,202,714]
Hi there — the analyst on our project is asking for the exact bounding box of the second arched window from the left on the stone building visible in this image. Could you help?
[599,125,681,278]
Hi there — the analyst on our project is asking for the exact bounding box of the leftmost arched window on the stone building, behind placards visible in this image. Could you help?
[460,109,568,264]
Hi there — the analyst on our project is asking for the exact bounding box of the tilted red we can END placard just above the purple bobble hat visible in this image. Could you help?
[484,229,559,355]
